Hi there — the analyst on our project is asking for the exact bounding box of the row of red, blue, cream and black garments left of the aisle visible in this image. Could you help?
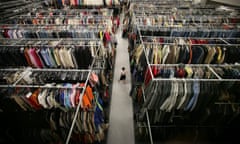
[0,40,105,69]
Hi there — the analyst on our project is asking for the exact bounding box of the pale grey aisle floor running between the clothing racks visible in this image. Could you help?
[107,16,134,144]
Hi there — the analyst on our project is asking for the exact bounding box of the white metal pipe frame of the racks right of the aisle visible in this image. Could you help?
[132,0,240,144]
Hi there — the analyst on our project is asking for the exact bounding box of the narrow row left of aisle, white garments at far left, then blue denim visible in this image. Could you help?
[0,25,107,39]
